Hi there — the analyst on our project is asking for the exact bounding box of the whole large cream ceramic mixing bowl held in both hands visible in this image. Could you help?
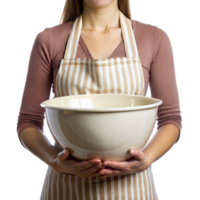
[40,94,162,161]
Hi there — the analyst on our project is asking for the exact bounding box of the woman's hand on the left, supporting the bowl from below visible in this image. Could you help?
[52,149,104,178]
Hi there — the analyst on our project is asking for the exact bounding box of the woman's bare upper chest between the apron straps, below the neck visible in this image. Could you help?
[81,29,123,59]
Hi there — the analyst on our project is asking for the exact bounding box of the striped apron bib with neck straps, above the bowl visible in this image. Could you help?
[55,11,144,97]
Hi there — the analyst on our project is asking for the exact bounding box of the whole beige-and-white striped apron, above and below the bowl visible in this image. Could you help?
[40,11,159,200]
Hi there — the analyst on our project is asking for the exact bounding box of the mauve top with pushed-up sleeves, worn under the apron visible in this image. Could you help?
[16,19,182,150]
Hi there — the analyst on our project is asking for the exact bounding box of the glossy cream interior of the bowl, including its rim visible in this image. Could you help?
[43,94,161,109]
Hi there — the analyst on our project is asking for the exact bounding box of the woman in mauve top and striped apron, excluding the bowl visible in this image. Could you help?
[18,0,181,200]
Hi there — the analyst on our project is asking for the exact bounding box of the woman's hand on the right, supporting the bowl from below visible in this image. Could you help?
[99,149,151,178]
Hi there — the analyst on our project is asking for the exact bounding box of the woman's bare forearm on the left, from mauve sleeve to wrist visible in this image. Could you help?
[20,127,59,168]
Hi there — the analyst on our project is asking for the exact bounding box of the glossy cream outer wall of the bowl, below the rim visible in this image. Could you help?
[45,107,158,161]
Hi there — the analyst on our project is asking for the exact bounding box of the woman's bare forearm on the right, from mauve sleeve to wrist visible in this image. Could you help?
[142,124,179,165]
